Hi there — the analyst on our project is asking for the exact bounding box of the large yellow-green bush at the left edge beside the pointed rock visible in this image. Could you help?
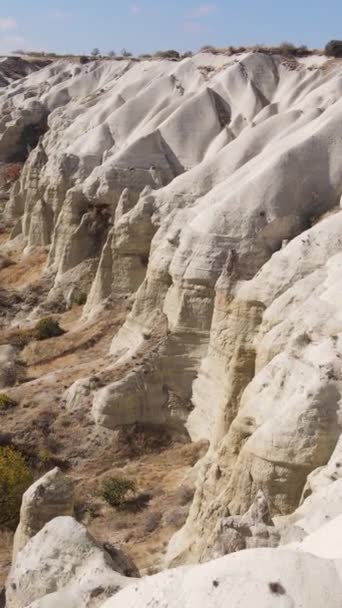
[0,447,33,530]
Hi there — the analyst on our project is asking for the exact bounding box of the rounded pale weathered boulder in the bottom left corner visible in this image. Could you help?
[6,517,133,608]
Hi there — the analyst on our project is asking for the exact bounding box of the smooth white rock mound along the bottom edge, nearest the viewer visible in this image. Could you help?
[103,549,342,608]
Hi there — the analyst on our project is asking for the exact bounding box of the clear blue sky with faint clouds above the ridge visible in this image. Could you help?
[0,0,342,53]
